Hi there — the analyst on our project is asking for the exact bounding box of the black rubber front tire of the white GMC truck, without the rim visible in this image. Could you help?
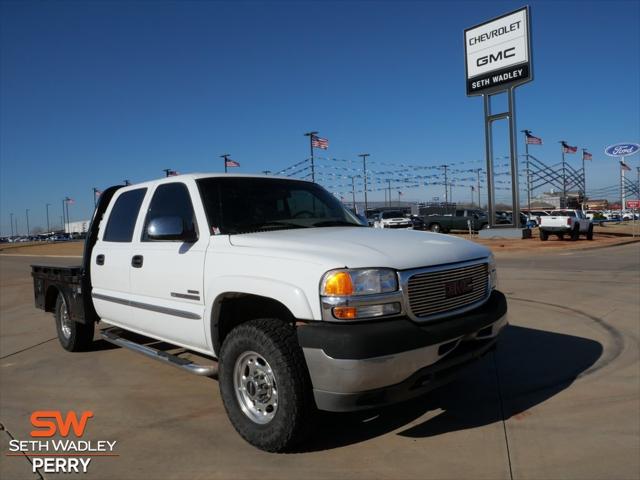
[219,318,315,452]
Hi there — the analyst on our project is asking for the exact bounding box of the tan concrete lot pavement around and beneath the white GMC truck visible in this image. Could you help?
[0,243,640,480]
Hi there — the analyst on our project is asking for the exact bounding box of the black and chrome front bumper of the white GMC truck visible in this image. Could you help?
[298,291,507,412]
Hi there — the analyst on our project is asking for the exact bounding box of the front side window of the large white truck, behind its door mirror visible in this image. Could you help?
[142,182,197,242]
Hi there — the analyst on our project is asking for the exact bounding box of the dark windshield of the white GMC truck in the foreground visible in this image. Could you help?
[197,177,363,235]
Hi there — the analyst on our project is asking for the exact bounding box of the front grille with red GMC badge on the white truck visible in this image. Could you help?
[407,263,489,318]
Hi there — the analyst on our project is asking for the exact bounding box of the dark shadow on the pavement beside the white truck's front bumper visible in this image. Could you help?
[300,326,603,452]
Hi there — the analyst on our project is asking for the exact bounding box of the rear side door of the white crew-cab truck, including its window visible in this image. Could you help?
[89,188,147,327]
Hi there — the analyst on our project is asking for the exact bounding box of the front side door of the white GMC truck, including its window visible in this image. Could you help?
[131,182,209,349]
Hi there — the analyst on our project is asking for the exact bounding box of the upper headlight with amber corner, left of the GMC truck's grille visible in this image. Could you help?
[320,268,398,297]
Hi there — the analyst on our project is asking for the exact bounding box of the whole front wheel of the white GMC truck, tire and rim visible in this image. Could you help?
[220,319,315,452]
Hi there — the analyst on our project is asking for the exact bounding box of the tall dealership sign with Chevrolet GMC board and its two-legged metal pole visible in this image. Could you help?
[464,7,533,228]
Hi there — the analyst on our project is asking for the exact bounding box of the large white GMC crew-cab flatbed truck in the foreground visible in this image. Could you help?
[32,174,507,451]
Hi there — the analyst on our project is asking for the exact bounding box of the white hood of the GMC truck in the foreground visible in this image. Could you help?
[229,227,490,270]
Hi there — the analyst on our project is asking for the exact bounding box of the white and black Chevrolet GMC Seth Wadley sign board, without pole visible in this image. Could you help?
[464,8,531,95]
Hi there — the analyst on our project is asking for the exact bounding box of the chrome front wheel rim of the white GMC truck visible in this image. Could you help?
[233,351,278,425]
